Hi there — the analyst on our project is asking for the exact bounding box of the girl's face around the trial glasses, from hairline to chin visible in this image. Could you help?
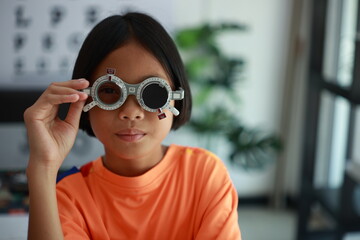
[89,41,174,159]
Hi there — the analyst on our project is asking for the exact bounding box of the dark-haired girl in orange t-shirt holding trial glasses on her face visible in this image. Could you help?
[24,13,240,240]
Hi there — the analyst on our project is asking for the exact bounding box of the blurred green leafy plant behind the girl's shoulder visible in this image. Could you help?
[175,23,282,169]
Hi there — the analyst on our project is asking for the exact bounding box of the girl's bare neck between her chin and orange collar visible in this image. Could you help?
[103,146,167,177]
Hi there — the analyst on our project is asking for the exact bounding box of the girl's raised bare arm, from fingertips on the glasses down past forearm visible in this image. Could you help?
[24,80,89,240]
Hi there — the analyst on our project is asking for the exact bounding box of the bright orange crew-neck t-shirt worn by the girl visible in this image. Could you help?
[57,145,241,240]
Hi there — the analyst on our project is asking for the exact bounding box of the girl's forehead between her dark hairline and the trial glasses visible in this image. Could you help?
[91,41,171,84]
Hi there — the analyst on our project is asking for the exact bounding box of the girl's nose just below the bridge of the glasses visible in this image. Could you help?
[119,96,145,121]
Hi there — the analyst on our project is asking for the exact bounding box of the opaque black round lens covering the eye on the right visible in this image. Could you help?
[141,83,168,109]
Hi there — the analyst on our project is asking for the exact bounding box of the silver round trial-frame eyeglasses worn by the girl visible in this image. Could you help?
[82,68,184,119]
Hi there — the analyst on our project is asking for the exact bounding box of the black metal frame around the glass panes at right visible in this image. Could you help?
[297,0,360,240]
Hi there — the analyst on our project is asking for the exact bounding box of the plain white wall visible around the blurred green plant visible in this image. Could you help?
[170,0,292,196]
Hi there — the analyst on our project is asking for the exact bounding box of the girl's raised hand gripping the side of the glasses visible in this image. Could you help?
[24,79,89,172]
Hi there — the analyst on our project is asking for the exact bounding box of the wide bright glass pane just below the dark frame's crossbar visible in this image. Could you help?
[314,91,350,188]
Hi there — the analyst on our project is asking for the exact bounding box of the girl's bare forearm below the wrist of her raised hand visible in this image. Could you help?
[27,164,63,240]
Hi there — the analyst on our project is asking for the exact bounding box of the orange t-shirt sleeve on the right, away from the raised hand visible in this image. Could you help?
[196,152,241,240]
